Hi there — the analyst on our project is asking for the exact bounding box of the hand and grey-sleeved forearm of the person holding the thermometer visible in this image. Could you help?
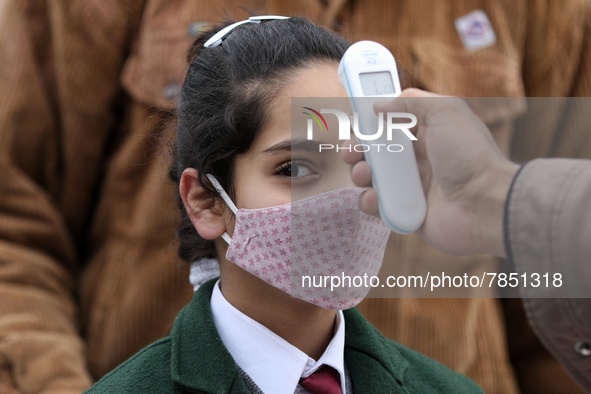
[343,89,591,392]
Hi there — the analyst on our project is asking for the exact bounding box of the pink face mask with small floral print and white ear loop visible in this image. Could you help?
[207,175,390,310]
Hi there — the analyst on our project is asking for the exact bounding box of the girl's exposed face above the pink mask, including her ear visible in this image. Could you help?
[179,63,354,260]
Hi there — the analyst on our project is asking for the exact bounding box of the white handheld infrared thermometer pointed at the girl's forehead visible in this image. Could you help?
[338,41,427,234]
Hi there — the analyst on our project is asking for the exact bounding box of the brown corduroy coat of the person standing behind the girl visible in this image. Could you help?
[0,0,591,393]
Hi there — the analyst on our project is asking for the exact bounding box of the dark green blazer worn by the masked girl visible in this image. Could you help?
[87,281,482,394]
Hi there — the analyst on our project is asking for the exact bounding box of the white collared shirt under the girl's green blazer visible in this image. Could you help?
[211,280,347,394]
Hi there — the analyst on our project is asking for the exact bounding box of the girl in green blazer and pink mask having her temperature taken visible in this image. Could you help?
[89,17,480,393]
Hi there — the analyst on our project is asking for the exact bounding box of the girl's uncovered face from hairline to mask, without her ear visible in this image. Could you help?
[234,63,353,209]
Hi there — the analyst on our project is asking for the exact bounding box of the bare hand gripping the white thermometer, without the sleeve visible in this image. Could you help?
[344,89,519,257]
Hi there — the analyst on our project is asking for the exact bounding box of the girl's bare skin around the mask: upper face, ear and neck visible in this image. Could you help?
[180,63,370,318]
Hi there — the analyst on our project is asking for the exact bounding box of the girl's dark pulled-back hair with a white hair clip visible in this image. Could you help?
[170,17,410,262]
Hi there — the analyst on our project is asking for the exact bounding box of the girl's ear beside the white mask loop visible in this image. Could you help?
[179,168,226,240]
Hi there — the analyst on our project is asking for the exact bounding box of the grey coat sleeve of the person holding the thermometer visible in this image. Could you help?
[504,159,591,391]
